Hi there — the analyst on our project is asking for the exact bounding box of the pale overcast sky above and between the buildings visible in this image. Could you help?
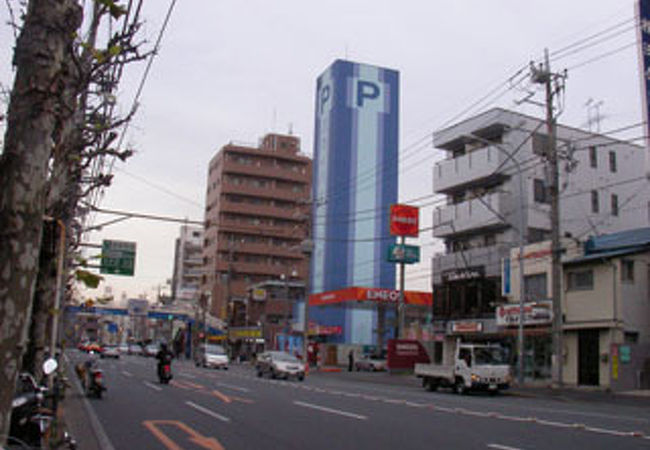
[0,0,643,301]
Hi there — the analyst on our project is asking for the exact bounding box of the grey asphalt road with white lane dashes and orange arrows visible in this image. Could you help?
[68,351,650,450]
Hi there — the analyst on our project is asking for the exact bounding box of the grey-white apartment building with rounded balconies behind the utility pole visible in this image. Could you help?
[432,108,650,358]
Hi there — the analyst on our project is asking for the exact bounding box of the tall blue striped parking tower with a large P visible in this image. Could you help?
[309,60,399,345]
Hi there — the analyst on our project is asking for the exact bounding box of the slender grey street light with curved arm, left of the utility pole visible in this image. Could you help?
[460,134,525,385]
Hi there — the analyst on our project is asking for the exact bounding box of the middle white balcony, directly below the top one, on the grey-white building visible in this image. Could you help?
[433,192,513,238]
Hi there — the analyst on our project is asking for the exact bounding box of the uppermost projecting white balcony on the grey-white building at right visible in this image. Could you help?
[433,146,507,194]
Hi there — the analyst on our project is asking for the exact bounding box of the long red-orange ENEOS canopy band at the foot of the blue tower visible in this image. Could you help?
[309,287,433,306]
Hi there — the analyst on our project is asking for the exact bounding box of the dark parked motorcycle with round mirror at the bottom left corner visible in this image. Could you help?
[7,358,76,448]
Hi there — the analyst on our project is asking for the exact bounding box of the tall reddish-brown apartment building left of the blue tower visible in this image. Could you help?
[201,134,312,327]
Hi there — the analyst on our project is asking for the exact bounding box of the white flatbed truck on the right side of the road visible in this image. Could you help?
[415,343,512,394]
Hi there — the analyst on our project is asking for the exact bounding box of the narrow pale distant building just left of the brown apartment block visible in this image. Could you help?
[172,225,203,303]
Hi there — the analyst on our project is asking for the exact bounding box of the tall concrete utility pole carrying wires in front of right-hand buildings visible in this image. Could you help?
[531,49,566,387]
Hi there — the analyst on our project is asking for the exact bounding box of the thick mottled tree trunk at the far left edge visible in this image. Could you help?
[0,0,82,436]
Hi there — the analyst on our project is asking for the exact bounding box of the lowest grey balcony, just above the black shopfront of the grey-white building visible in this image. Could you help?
[431,244,510,284]
